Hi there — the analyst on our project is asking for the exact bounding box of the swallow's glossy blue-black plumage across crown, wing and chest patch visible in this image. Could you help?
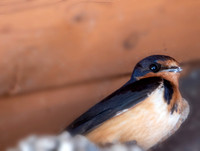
[66,55,175,135]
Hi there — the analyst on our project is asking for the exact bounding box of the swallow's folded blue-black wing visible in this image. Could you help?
[66,77,162,135]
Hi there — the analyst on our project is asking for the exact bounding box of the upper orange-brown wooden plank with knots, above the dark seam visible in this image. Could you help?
[0,0,200,94]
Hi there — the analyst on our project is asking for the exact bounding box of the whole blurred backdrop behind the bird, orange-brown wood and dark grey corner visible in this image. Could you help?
[0,0,200,151]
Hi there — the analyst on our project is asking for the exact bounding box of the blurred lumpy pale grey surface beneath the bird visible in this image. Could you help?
[7,132,143,151]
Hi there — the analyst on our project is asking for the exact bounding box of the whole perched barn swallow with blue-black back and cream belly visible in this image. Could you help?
[66,55,189,149]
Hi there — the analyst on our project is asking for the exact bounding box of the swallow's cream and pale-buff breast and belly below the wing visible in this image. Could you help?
[86,85,180,149]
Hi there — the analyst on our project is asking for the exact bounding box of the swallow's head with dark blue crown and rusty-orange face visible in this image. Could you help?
[131,55,182,85]
